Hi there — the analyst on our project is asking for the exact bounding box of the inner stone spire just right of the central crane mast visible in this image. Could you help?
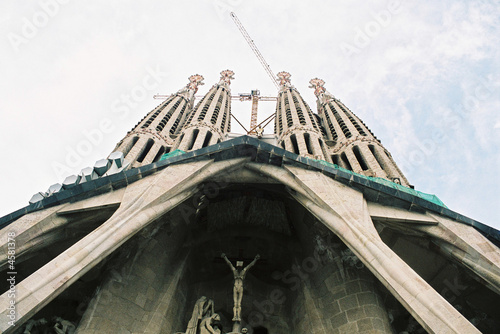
[274,72,325,160]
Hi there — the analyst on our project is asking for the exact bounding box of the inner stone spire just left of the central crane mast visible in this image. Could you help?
[176,70,234,151]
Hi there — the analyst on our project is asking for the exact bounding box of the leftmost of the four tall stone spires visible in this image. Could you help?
[113,74,203,168]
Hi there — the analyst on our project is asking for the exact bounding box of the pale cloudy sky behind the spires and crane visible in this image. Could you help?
[0,0,500,229]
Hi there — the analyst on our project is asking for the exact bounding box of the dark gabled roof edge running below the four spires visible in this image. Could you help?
[0,136,500,247]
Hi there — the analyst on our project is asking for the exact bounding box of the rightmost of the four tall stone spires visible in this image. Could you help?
[309,78,409,186]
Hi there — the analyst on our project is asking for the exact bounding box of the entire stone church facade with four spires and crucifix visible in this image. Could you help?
[0,70,500,334]
